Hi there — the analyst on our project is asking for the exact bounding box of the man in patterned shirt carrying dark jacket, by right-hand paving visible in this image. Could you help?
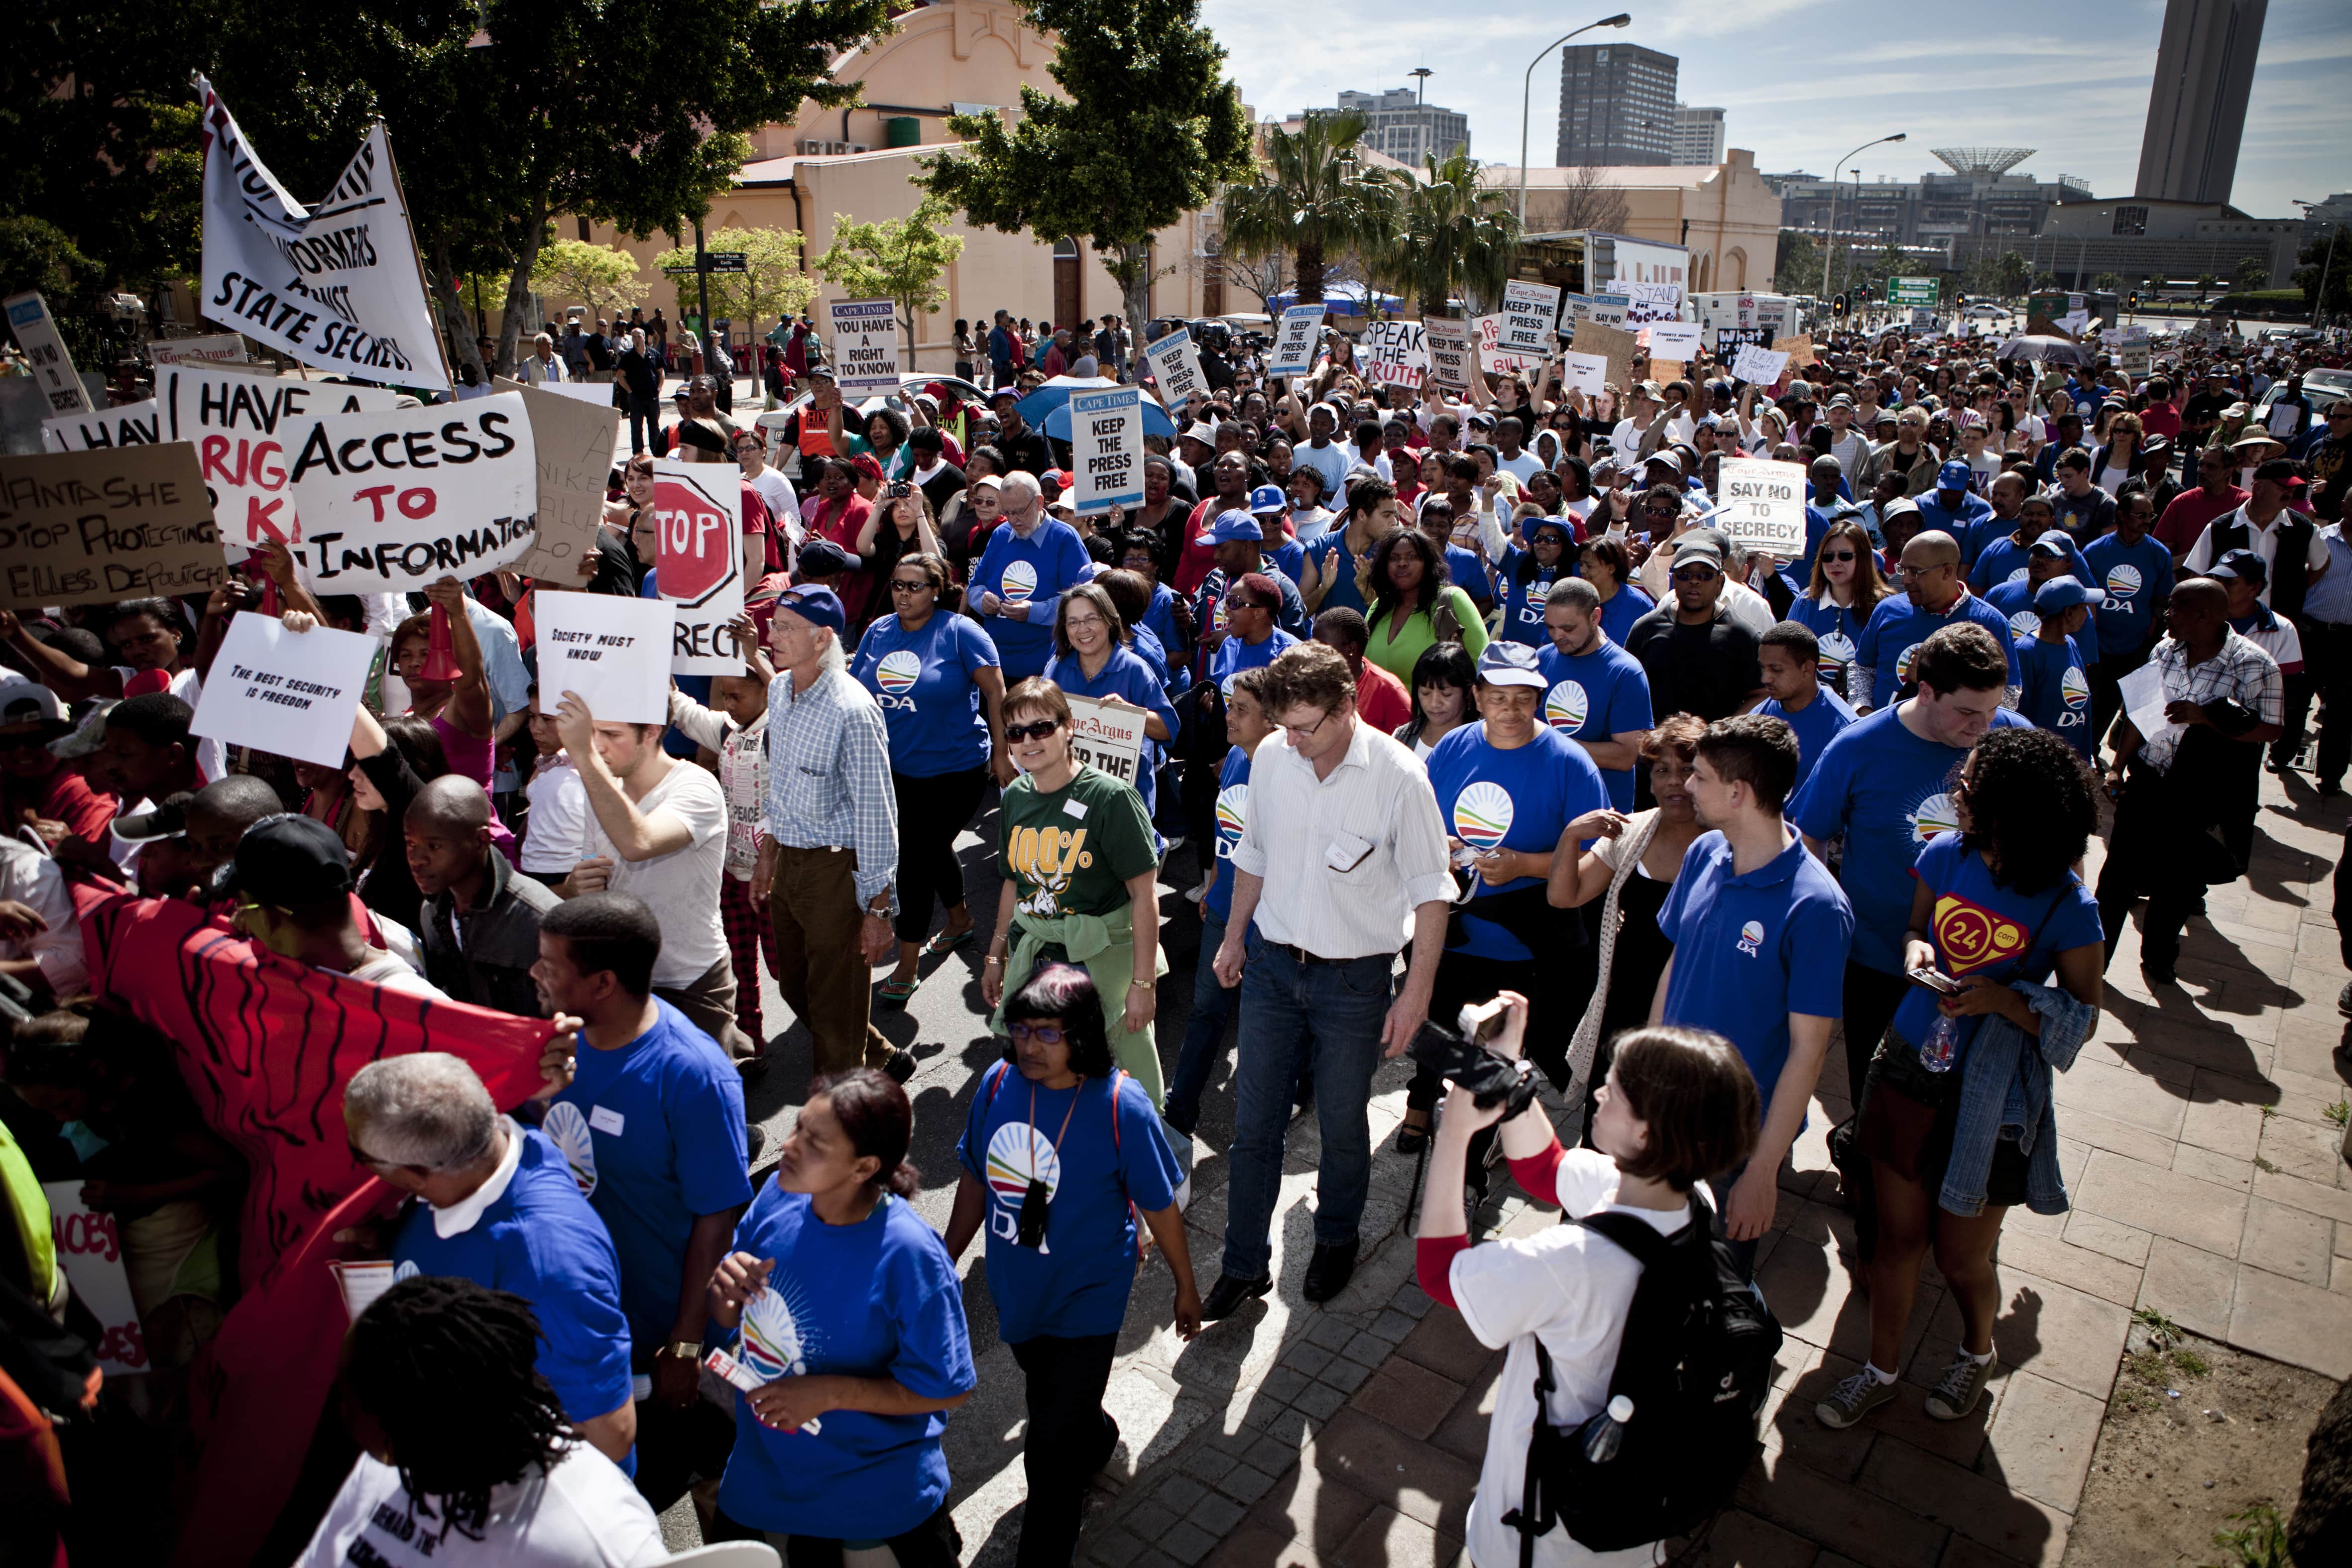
[2098,576,2286,985]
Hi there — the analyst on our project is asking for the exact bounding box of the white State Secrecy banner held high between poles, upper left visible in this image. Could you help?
[195,78,449,393]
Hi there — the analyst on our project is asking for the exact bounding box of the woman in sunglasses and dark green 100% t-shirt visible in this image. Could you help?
[981,677,1167,1107]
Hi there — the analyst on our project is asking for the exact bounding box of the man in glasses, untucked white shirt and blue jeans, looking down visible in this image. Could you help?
[1202,644,1453,1319]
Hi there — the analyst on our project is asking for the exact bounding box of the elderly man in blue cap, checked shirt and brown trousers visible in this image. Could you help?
[750,588,915,1084]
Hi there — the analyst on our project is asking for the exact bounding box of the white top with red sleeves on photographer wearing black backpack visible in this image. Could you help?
[1446,1149,1708,1568]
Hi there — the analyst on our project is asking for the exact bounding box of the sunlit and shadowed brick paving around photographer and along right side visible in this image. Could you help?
[1049,776,2352,1568]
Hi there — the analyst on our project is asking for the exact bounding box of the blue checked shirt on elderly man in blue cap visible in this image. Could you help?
[760,670,899,914]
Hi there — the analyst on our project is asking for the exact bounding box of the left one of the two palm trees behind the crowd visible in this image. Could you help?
[1225,111,1388,306]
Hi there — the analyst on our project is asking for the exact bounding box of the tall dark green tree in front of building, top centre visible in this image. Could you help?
[912,0,1249,352]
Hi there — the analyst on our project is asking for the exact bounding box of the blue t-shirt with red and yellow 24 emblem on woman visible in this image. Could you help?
[1893,832,2105,1051]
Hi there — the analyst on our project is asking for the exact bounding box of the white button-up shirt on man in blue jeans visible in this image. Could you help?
[1232,719,1453,959]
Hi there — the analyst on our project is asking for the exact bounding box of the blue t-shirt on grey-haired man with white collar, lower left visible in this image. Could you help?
[393,1121,635,1422]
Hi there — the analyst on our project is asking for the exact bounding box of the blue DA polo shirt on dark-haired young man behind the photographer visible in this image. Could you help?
[1658,832,1856,1115]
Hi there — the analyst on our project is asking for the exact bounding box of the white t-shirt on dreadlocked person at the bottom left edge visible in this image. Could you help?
[301,1444,670,1568]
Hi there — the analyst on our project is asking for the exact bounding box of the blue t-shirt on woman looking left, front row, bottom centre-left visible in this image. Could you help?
[720,1182,978,1540]
